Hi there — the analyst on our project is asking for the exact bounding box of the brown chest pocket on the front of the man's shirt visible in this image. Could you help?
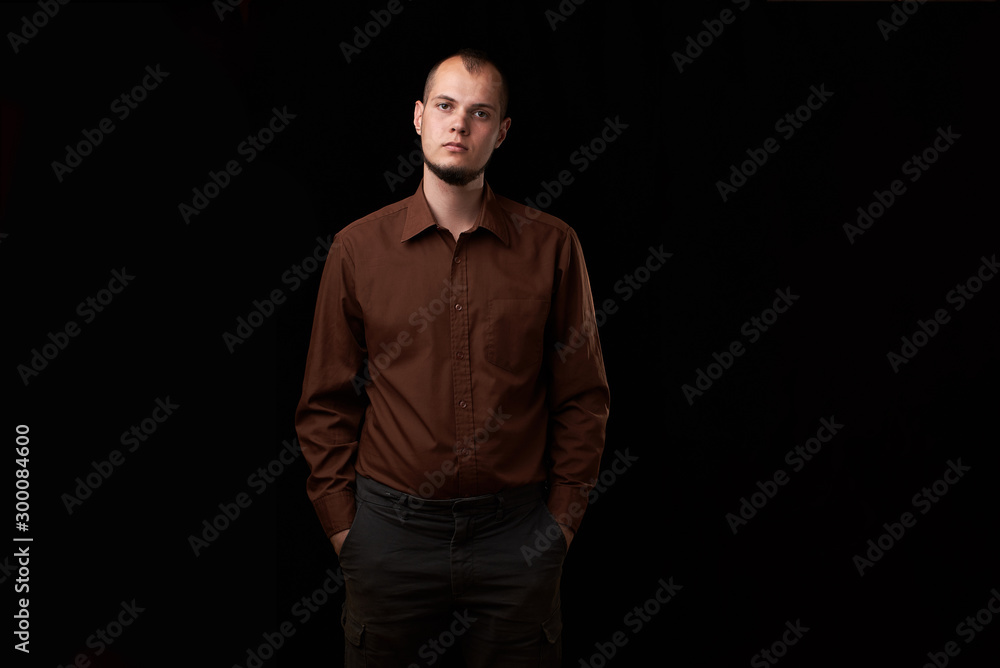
[486,299,549,372]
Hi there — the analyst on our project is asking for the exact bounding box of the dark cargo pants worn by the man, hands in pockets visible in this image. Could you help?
[340,476,566,668]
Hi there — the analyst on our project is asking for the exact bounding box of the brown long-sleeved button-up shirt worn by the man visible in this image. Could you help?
[296,182,609,536]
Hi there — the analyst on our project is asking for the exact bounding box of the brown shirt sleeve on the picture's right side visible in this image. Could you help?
[546,229,610,532]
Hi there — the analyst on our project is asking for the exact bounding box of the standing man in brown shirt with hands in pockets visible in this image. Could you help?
[296,50,609,668]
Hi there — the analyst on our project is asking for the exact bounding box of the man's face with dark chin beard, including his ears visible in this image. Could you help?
[413,57,510,186]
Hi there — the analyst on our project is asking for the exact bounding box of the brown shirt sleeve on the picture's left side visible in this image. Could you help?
[295,236,368,536]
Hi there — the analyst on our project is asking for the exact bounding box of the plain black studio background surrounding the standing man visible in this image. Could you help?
[0,0,1000,667]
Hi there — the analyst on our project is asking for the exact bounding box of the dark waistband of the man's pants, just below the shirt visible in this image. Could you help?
[355,475,547,516]
